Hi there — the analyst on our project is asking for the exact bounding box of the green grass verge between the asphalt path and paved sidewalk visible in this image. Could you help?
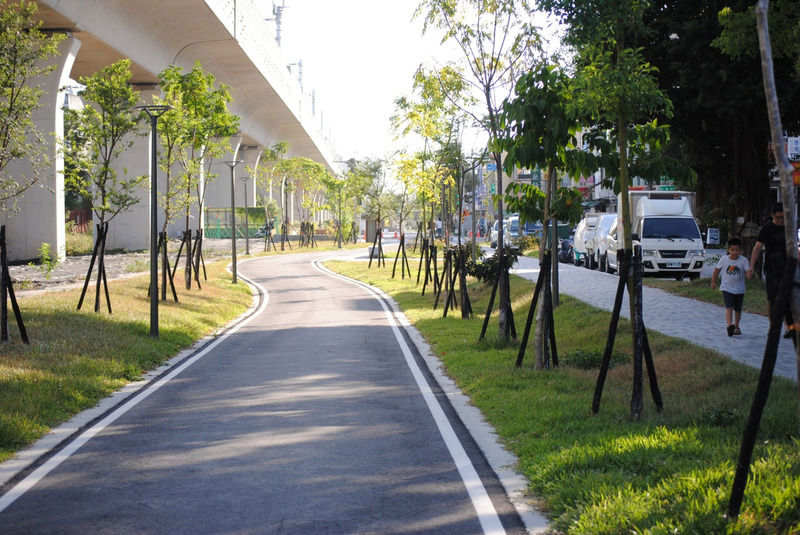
[327,262,800,534]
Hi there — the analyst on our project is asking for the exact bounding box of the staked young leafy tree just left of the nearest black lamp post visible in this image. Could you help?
[64,59,146,313]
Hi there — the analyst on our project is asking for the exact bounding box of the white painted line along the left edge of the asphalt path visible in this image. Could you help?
[0,275,269,513]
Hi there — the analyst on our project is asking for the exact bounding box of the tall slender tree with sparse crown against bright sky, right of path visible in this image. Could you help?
[417,0,539,340]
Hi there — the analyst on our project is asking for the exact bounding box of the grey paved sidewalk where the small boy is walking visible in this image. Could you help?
[512,258,797,380]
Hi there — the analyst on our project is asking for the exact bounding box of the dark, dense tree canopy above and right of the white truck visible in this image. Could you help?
[636,0,800,224]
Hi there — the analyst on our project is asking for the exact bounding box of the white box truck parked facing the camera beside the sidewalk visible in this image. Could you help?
[617,191,705,280]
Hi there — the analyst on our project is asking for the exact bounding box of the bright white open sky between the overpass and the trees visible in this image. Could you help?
[256,0,456,160]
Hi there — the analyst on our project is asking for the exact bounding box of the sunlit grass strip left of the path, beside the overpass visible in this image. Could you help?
[0,262,252,461]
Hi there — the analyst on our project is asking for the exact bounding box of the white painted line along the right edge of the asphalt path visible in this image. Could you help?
[311,258,506,534]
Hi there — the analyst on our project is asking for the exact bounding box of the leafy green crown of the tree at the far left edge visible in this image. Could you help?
[0,0,64,218]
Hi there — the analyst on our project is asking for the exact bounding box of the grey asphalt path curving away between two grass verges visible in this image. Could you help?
[0,253,541,534]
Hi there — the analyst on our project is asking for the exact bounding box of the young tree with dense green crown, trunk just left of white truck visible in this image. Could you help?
[540,0,692,418]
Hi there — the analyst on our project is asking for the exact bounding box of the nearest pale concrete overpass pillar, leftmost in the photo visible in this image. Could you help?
[6,37,81,260]
